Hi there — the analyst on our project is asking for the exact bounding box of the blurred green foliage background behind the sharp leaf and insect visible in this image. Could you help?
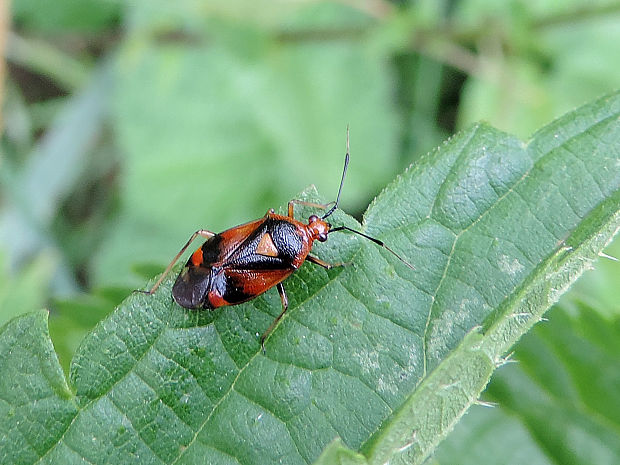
[0,0,620,463]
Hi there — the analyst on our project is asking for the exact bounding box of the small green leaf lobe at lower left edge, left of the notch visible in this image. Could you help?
[0,311,78,464]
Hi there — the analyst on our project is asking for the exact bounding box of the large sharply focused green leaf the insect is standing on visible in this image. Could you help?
[0,94,620,464]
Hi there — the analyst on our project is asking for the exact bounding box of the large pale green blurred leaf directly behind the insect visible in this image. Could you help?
[103,2,398,284]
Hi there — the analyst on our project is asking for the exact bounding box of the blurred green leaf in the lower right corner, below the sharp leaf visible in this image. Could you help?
[435,264,620,465]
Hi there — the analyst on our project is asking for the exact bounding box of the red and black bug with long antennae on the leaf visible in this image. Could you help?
[146,128,413,351]
